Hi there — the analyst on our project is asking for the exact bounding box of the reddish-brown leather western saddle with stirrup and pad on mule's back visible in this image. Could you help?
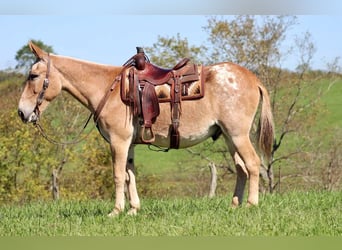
[121,47,204,148]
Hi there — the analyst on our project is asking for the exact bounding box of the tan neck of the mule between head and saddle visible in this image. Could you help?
[55,56,121,111]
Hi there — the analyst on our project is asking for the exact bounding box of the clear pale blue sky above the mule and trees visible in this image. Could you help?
[0,14,342,70]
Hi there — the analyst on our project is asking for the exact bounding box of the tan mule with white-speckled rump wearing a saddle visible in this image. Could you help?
[18,43,274,216]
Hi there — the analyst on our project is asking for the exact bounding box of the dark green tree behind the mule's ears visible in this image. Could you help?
[15,39,55,72]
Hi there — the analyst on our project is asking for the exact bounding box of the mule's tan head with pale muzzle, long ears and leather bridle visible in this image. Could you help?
[18,42,62,122]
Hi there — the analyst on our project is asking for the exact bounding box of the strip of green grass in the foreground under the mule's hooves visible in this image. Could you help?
[0,192,342,236]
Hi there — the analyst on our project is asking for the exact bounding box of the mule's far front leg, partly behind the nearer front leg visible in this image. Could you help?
[126,145,140,215]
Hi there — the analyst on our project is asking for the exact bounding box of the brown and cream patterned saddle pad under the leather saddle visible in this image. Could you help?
[121,65,204,103]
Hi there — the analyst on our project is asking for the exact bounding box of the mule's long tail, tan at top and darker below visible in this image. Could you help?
[257,84,274,159]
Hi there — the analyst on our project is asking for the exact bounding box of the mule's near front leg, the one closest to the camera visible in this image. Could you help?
[108,139,130,217]
